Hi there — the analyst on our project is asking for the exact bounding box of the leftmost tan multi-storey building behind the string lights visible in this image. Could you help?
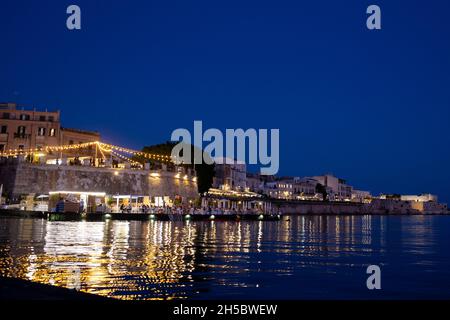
[0,103,100,152]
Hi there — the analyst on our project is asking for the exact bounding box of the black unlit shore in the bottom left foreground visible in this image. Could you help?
[0,277,110,301]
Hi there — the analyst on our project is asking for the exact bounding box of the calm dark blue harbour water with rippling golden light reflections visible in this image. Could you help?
[0,216,450,299]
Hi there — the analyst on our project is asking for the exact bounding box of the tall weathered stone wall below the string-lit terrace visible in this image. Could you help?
[0,161,198,198]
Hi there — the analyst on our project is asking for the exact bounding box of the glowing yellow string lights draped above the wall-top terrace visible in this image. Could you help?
[0,141,173,164]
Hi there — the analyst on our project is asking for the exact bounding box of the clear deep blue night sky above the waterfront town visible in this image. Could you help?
[0,0,450,201]
